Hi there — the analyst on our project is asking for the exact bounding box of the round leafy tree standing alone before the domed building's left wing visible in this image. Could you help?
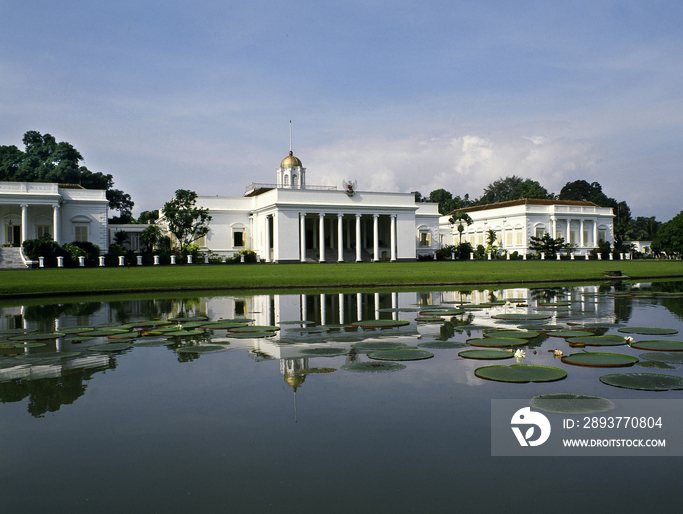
[161,189,212,248]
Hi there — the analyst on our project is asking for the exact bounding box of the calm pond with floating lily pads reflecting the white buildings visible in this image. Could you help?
[0,282,683,513]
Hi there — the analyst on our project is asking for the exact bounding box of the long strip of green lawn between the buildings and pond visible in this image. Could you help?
[0,260,683,297]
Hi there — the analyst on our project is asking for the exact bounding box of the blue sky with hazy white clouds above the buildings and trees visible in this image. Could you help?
[0,0,683,221]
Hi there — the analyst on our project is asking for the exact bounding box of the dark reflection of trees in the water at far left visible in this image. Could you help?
[0,358,116,418]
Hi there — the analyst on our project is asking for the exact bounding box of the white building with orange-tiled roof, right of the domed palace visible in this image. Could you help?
[439,198,614,256]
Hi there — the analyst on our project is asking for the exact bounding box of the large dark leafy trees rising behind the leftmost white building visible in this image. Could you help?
[0,130,135,222]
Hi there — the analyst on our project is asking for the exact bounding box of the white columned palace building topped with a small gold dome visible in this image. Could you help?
[186,147,440,263]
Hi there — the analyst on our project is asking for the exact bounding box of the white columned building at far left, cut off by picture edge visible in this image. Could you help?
[0,182,109,253]
